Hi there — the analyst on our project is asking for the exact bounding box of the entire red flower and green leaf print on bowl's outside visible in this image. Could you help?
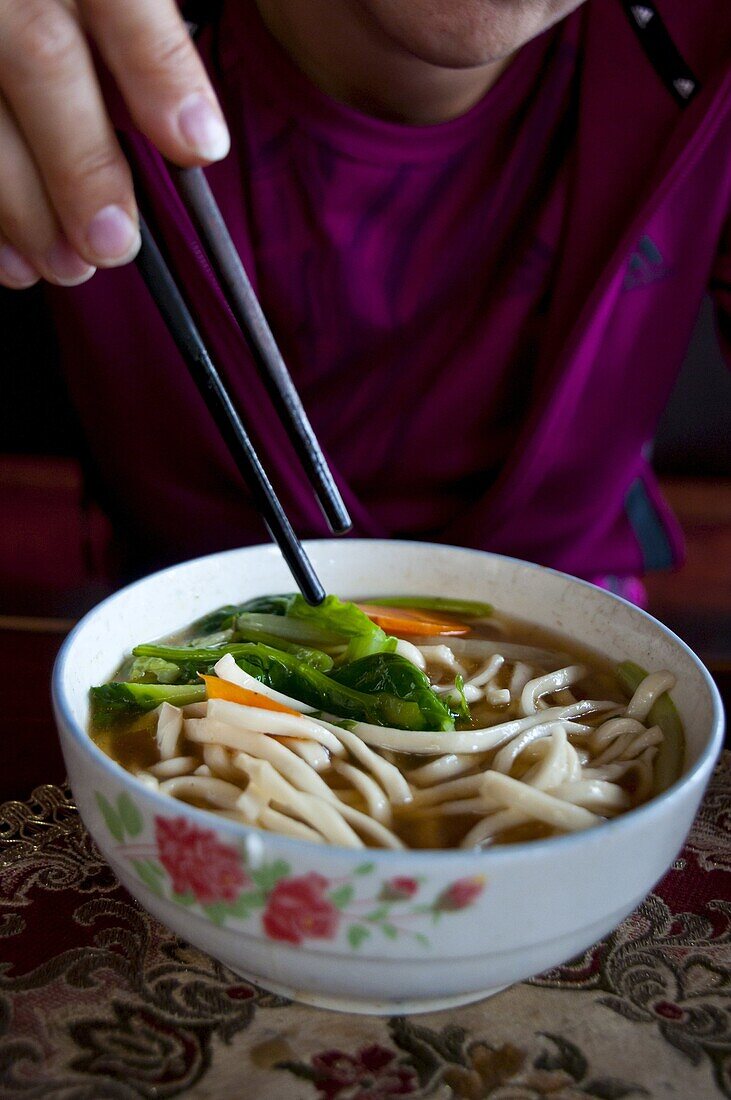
[96,791,486,950]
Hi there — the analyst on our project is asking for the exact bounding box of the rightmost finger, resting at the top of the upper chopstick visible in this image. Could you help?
[80,0,230,166]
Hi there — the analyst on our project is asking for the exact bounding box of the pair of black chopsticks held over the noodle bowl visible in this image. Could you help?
[136,167,352,605]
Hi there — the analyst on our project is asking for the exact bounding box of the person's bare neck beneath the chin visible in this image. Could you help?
[256,0,510,125]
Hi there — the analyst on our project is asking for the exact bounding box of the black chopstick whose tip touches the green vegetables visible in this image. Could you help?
[131,218,325,605]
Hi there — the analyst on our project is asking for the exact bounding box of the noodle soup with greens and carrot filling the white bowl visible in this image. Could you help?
[90,595,684,848]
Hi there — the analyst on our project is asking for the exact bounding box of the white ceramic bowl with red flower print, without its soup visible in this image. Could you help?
[53,540,722,1013]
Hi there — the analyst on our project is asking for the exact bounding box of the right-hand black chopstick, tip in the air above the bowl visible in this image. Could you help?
[169,165,352,535]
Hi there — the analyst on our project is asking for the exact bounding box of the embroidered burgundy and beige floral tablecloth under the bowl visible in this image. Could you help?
[0,754,731,1100]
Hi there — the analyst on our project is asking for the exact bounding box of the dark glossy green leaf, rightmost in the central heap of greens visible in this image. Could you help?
[330,653,454,729]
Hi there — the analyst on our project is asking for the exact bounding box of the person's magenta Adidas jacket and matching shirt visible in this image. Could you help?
[48,0,731,587]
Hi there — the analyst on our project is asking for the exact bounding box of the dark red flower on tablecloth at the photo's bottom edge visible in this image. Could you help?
[312,1043,417,1100]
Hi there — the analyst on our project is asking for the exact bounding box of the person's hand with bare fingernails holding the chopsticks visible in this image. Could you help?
[0,0,229,289]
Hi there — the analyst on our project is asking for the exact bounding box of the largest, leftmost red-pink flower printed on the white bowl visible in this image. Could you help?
[155,817,250,904]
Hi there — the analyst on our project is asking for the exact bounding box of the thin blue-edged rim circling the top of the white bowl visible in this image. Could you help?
[51,538,724,870]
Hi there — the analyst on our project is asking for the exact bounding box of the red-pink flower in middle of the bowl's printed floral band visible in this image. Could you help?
[262,871,340,944]
